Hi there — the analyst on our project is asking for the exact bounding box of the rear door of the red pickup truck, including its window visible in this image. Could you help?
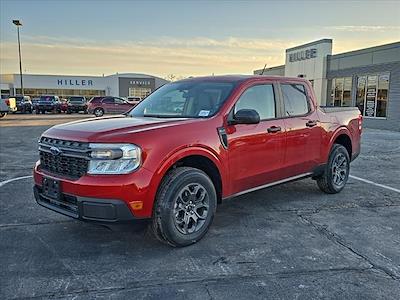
[280,82,322,177]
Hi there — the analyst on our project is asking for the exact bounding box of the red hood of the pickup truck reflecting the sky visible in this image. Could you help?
[43,116,197,142]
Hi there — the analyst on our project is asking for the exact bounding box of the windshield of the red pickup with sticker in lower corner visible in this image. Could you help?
[129,81,234,118]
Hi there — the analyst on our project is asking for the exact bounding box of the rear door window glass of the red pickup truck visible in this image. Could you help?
[281,84,310,116]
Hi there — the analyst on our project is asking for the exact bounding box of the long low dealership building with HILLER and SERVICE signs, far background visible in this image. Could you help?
[0,73,168,98]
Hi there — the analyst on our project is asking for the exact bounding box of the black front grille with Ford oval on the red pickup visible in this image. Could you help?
[39,137,89,179]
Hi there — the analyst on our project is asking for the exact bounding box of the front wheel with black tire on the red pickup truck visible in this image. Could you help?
[152,167,217,247]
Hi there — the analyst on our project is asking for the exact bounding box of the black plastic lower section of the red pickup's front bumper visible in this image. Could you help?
[33,185,136,223]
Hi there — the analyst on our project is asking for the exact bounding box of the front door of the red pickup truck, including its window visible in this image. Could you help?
[226,83,285,194]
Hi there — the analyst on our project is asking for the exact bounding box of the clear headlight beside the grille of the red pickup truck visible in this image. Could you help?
[88,143,142,174]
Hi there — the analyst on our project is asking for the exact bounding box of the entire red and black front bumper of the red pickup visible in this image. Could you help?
[33,163,156,222]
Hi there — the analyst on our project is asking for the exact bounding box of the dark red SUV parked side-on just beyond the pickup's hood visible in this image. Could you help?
[87,96,135,117]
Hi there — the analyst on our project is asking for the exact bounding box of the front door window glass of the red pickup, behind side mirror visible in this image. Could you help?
[235,84,276,120]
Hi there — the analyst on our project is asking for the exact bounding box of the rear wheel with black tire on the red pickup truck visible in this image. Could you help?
[317,144,350,194]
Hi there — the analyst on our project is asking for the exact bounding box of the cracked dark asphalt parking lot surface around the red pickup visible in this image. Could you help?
[0,115,400,299]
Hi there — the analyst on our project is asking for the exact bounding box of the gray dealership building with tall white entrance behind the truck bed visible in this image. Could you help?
[254,39,400,131]
